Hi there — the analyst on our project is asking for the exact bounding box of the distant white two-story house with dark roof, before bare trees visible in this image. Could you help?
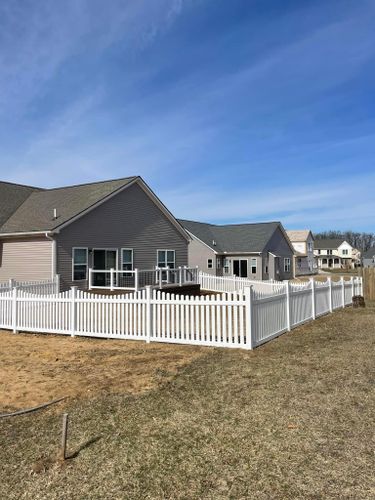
[314,239,358,269]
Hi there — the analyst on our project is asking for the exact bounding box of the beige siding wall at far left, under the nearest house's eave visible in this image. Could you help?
[0,238,52,282]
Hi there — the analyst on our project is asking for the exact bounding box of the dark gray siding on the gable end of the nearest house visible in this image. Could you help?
[56,184,188,290]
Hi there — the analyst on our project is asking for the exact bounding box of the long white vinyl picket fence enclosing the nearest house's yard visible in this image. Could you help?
[0,278,362,349]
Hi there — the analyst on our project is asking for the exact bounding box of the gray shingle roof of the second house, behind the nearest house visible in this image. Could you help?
[179,219,282,253]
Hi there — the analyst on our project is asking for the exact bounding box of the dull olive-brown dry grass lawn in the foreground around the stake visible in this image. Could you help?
[0,306,375,500]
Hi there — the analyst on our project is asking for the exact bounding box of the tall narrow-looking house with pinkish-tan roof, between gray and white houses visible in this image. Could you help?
[286,229,317,276]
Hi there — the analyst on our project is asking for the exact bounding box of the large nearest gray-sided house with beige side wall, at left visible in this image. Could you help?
[0,177,190,290]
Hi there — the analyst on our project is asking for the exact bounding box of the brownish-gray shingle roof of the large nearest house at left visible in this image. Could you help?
[0,177,137,234]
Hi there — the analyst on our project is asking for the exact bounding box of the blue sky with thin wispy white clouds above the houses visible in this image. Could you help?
[0,0,375,231]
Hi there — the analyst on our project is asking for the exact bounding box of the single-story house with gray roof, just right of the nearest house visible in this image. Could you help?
[179,220,293,280]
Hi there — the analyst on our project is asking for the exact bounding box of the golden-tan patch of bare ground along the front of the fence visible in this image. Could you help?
[0,331,206,411]
